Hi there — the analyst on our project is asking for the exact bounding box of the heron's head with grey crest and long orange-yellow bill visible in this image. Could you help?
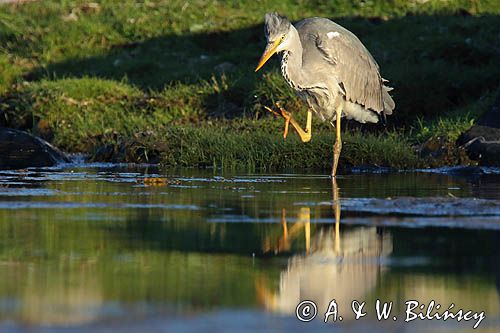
[255,13,291,71]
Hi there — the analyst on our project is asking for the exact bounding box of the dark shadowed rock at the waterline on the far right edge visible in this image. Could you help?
[457,93,500,166]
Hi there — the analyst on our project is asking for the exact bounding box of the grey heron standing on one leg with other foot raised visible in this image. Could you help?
[255,13,395,177]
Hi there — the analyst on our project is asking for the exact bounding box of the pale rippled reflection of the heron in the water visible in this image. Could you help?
[256,180,392,319]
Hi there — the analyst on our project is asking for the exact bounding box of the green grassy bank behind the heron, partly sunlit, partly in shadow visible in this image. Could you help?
[0,0,500,169]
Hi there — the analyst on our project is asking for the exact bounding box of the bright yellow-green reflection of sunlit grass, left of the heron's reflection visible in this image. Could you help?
[0,246,277,324]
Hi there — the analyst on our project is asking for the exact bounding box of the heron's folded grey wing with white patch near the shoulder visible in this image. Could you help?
[298,20,384,113]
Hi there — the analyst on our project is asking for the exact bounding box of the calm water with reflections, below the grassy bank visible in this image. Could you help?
[0,164,500,333]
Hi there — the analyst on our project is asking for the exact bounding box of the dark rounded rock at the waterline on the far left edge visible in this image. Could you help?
[0,127,69,169]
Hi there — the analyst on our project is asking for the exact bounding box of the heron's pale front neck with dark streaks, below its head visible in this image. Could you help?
[281,26,303,90]
